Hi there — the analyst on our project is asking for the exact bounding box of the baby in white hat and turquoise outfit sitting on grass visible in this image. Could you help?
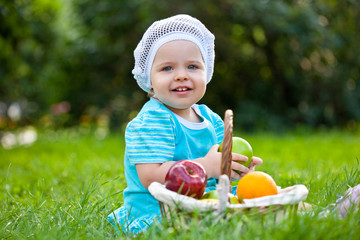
[109,15,262,233]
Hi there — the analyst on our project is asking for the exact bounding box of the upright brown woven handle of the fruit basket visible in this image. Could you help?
[220,109,233,181]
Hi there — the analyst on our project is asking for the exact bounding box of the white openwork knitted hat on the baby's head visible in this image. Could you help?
[132,14,215,92]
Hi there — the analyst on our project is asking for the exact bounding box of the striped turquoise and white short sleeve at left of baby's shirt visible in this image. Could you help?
[125,110,175,164]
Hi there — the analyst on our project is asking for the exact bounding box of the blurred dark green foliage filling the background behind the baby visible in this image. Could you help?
[0,0,360,131]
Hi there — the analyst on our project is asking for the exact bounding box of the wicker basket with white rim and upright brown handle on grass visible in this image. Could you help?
[149,110,309,216]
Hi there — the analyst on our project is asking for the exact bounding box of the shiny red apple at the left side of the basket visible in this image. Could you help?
[165,160,207,199]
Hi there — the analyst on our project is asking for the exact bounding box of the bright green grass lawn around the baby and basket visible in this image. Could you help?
[0,127,360,239]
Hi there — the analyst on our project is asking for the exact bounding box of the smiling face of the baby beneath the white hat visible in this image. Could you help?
[150,40,206,113]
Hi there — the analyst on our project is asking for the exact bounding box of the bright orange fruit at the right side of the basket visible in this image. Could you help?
[236,171,278,199]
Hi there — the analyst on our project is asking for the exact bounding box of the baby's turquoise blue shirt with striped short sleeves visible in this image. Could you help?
[120,98,224,231]
